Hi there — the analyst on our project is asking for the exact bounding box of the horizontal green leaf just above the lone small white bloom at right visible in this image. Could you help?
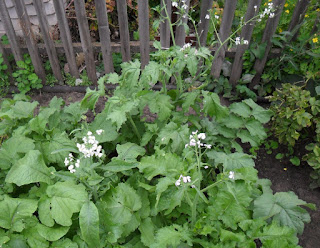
[207,151,254,171]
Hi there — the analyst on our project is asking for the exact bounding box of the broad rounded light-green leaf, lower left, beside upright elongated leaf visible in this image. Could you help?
[47,181,88,226]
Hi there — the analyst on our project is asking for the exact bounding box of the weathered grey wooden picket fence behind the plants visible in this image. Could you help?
[0,0,316,87]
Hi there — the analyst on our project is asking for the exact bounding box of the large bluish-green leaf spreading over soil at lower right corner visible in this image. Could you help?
[253,192,315,234]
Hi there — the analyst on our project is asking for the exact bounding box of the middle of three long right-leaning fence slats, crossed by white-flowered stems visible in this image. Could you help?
[229,0,261,87]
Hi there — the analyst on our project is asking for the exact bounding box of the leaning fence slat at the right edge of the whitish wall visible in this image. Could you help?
[53,0,79,78]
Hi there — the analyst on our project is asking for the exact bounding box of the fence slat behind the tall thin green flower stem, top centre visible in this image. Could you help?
[160,0,172,48]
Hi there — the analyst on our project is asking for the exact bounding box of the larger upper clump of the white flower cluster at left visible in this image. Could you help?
[77,130,103,158]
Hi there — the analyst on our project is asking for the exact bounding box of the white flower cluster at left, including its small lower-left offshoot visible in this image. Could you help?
[64,129,104,173]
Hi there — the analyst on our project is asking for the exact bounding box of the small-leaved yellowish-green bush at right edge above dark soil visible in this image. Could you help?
[270,84,320,188]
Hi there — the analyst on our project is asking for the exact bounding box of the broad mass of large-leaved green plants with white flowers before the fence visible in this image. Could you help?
[0,61,314,248]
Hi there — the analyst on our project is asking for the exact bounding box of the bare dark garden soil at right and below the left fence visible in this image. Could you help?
[26,93,320,248]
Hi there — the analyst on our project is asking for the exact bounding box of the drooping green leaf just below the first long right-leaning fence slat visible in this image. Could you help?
[202,91,229,120]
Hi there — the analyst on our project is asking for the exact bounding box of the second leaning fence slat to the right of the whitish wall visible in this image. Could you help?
[74,0,97,83]
